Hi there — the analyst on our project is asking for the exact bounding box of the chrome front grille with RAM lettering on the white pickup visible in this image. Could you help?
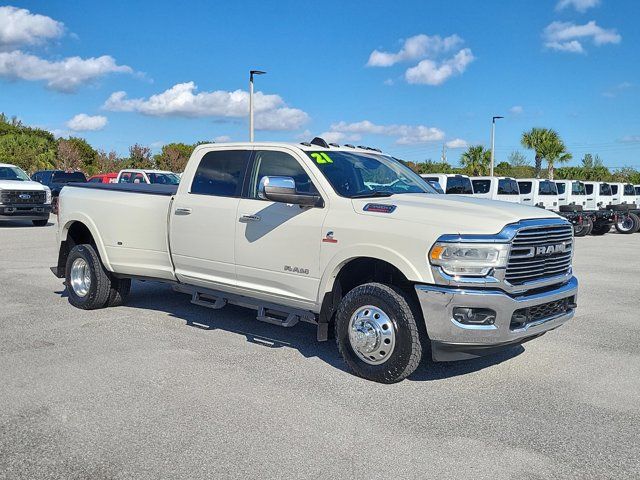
[505,223,573,285]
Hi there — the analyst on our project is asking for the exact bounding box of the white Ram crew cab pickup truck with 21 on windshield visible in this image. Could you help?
[52,139,578,383]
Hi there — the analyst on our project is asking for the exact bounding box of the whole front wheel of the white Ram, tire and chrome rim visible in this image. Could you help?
[335,283,422,383]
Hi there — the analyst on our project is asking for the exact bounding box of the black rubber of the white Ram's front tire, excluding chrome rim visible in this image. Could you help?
[335,283,421,383]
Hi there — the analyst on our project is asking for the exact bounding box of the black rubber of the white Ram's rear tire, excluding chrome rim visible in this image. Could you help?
[65,244,110,310]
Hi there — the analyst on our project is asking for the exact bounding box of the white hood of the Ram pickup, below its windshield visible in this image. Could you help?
[352,194,559,234]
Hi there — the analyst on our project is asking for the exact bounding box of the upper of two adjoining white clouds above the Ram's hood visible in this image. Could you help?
[367,34,462,67]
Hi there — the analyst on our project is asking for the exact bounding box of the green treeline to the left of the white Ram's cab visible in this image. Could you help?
[0,113,204,175]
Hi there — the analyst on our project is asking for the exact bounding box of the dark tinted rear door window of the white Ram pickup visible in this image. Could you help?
[191,150,251,197]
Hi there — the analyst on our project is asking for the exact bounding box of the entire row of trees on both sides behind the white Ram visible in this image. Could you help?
[0,113,640,184]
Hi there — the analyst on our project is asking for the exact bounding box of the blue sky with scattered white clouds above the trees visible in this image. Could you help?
[0,0,640,168]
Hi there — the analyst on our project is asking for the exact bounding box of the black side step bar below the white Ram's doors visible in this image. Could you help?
[173,283,318,327]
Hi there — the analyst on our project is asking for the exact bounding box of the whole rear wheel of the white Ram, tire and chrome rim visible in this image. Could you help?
[65,244,111,310]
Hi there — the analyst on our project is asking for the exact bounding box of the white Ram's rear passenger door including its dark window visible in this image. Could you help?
[169,149,251,288]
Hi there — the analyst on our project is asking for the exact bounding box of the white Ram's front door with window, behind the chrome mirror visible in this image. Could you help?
[236,148,328,302]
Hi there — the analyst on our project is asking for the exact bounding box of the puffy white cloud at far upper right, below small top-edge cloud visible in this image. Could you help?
[542,20,622,53]
